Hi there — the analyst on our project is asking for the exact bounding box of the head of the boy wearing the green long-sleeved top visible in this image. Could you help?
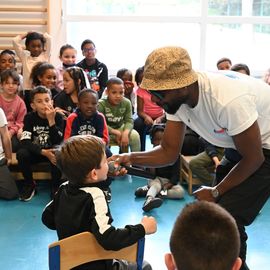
[107,77,125,106]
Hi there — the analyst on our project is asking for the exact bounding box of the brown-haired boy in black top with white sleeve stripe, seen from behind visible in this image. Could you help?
[42,135,156,270]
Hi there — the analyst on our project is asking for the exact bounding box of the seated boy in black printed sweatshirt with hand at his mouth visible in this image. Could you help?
[17,86,63,201]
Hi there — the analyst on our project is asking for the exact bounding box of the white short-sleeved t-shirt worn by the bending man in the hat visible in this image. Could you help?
[167,71,270,149]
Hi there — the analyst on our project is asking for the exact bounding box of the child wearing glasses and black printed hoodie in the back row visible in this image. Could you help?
[77,39,108,98]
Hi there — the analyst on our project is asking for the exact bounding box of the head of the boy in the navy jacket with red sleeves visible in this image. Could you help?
[78,89,98,117]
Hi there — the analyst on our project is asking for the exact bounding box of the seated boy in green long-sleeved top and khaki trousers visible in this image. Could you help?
[98,78,141,152]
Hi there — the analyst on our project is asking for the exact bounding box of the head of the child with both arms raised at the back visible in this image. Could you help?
[25,32,46,57]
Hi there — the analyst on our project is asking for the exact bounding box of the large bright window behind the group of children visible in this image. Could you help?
[63,0,270,76]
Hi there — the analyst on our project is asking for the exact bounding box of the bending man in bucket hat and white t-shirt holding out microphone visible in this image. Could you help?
[112,47,270,270]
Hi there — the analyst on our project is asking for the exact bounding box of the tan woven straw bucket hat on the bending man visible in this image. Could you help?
[141,47,198,90]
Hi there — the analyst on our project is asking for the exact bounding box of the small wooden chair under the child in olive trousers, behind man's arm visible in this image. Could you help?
[180,155,202,195]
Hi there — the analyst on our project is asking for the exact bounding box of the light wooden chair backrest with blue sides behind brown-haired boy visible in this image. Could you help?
[49,232,145,270]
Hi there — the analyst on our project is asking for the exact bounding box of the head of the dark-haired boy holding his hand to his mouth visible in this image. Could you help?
[30,86,53,118]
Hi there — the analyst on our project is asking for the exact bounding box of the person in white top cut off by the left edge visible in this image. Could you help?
[0,108,19,200]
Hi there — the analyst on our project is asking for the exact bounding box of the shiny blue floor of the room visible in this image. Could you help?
[0,142,270,270]
